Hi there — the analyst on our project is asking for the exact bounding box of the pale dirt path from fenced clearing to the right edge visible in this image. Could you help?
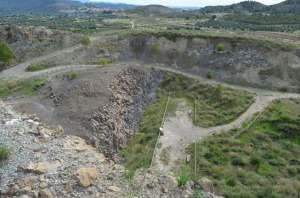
[154,89,300,172]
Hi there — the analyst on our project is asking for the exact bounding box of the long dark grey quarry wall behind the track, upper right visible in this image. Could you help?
[122,35,300,91]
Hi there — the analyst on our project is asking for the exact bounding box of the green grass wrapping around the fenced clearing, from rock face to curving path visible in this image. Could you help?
[120,72,252,170]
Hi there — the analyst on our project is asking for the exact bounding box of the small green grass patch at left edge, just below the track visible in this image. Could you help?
[0,78,45,97]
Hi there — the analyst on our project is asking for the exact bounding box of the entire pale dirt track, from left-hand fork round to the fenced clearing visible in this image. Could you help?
[0,42,300,171]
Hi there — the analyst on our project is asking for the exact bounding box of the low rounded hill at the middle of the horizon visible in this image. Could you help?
[126,5,173,15]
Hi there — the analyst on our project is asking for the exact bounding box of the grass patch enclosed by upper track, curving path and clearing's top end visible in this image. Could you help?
[158,72,253,127]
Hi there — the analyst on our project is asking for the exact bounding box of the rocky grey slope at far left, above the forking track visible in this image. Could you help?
[0,26,81,62]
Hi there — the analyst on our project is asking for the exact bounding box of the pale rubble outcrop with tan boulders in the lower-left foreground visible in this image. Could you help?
[0,102,125,198]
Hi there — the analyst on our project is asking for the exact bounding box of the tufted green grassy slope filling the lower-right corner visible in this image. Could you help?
[183,99,300,197]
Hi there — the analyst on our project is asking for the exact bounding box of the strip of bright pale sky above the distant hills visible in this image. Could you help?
[90,0,283,7]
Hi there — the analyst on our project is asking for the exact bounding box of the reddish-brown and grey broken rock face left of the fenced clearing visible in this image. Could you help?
[90,67,163,158]
